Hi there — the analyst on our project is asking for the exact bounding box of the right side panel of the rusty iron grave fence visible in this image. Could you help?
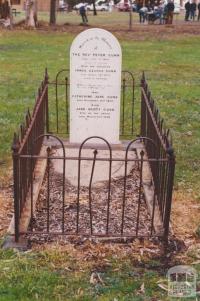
[141,73,175,237]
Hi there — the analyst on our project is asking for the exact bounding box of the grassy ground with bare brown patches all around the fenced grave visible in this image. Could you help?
[0,27,200,301]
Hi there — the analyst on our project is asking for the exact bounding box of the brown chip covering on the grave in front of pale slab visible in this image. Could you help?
[28,154,151,242]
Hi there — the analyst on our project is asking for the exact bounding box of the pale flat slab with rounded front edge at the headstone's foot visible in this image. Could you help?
[52,148,136,187]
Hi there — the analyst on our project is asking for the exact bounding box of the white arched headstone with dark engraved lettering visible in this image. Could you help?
[70,28,122,144]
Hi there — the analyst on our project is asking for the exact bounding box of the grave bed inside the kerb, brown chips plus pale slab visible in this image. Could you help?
[30,145,152,240]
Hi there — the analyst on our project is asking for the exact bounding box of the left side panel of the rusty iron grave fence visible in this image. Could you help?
[12,71,48,239]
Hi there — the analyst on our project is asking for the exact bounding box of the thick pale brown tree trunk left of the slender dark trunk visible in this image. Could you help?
[25,0,38,28]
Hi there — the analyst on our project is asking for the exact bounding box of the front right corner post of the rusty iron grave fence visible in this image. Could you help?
[164,147,176,241]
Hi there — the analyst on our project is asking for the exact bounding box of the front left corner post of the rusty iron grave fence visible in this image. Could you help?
[12,133,20,242]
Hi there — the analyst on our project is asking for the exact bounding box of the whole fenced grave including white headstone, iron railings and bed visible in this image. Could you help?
[9,29,175,242]
